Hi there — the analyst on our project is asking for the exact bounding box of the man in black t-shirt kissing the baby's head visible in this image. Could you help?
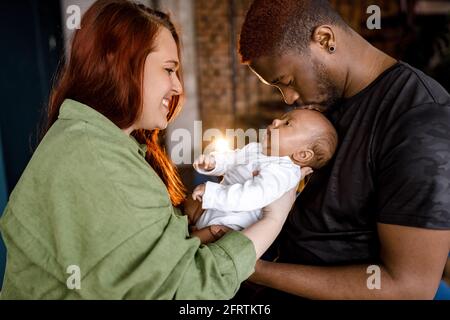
[239,0,450,299]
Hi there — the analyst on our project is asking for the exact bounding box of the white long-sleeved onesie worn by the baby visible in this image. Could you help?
[196,143,301,230]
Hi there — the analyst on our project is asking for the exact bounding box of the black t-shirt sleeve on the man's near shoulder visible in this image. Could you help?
[375,103,450,229]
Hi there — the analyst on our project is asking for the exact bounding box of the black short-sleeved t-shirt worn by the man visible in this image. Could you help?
[279,62,450,265]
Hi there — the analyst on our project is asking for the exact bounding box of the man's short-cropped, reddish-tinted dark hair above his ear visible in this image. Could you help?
[239,0,349,63]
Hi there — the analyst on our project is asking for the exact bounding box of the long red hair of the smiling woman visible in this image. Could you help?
[46,0,186,206]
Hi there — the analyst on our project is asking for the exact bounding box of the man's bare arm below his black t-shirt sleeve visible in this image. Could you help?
[250,223,450,299]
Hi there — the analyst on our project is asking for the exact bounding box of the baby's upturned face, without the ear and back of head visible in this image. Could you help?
[262,109,323,157]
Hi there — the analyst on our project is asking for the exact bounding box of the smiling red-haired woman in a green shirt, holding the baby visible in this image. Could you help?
[1,0,294,299]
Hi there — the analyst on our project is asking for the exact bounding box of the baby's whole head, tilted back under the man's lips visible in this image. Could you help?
[262,109,338,169]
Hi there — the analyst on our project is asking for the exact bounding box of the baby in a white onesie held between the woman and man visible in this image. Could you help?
[192,109,337,243]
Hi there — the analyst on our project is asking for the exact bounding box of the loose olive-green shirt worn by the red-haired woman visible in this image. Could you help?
[0,100,256,299]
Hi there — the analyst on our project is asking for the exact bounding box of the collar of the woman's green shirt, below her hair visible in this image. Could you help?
[58,99,147,157]
